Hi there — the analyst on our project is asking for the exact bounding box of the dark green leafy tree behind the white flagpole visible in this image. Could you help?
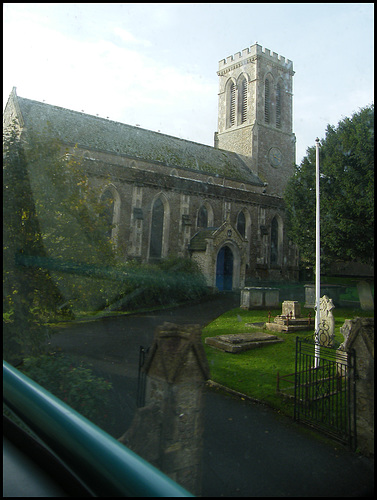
[284,105,374,268]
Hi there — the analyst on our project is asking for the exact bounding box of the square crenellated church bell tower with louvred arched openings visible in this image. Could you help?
[215,44,296,196]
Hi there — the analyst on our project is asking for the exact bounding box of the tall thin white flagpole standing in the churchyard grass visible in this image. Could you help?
[314,137,321,368]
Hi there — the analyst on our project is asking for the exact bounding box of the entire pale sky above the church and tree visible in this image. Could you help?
[3,3,374,164]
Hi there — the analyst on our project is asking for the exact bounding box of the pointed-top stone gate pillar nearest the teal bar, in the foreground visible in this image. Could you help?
[120,323,209,496]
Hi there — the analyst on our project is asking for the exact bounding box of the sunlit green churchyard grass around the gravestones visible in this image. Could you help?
[202,303,374,416]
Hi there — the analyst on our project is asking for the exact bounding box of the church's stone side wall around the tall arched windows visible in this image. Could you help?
[84,148,298,284]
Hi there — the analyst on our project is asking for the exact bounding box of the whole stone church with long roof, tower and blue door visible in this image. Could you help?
[3,44,298,290]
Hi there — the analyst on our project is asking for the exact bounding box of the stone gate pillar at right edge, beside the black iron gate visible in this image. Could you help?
[340,318,374,455]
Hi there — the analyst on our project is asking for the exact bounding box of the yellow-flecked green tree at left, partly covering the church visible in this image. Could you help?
[3,124,116,360]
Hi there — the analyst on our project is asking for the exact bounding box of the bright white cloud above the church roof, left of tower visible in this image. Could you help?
[4,12,217,144]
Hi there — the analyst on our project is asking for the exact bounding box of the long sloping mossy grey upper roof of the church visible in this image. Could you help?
[15,96,263,186]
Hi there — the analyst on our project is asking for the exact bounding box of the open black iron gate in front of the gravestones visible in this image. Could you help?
[294,338,356,449]
